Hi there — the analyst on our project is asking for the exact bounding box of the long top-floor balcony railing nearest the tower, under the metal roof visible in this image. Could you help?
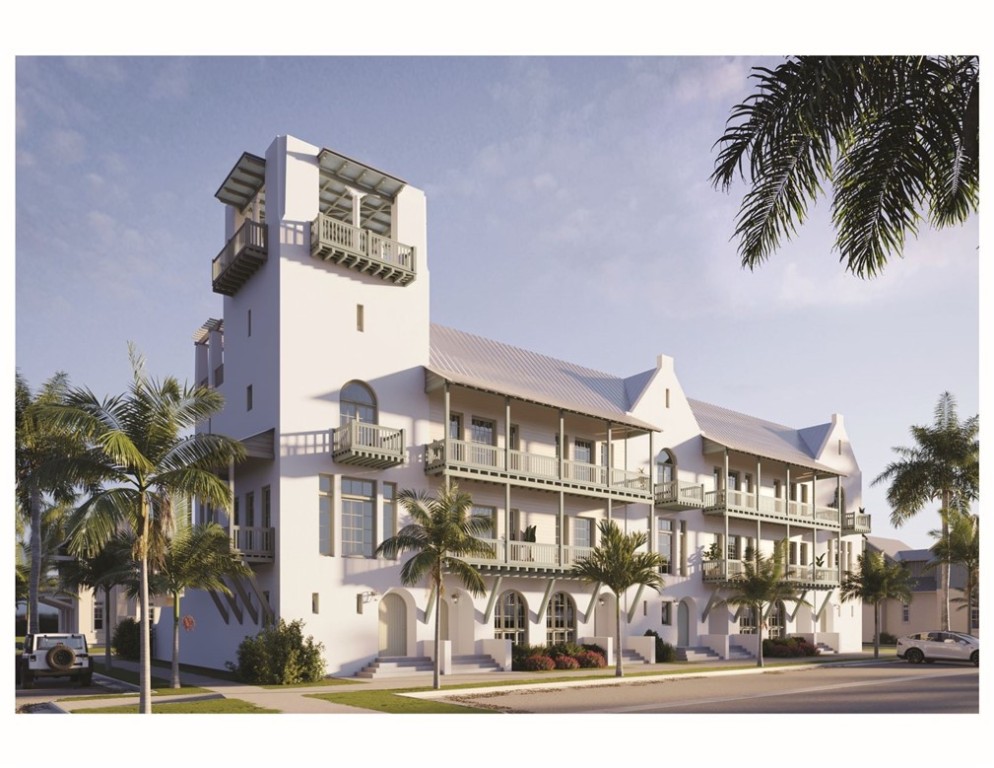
[425,439,651,501]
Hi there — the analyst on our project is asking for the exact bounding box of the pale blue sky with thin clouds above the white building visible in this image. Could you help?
[16,56,979,546]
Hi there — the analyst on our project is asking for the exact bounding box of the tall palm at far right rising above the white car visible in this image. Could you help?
[873,392,980,630]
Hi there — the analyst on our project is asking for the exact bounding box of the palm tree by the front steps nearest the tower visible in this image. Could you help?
[376,484,493,689]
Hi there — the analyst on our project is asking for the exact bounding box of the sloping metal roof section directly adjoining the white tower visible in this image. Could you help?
[428,323,659,431]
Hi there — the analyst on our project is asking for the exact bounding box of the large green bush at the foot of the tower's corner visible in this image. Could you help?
[227,619,324,685]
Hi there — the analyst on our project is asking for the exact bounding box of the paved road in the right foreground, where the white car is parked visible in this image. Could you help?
[448,662,980,714]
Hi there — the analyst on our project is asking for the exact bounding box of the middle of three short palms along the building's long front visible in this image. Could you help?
[571,520,663,677]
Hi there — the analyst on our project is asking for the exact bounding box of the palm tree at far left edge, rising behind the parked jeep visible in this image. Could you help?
[14,373,87,634]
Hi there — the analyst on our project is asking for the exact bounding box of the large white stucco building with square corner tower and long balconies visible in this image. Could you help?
[170,136,869,674]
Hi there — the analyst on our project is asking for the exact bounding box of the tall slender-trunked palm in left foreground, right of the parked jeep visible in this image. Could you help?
[47,346,245,714]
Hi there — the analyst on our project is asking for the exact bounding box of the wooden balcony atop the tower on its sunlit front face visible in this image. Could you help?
[311,214,417,285]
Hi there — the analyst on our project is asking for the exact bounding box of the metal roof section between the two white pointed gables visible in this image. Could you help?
[687,399,841,475]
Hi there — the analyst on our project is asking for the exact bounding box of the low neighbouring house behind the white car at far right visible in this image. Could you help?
[863,536,968,643]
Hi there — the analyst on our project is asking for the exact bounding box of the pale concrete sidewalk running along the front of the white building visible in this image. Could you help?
[53,653,886,715]
